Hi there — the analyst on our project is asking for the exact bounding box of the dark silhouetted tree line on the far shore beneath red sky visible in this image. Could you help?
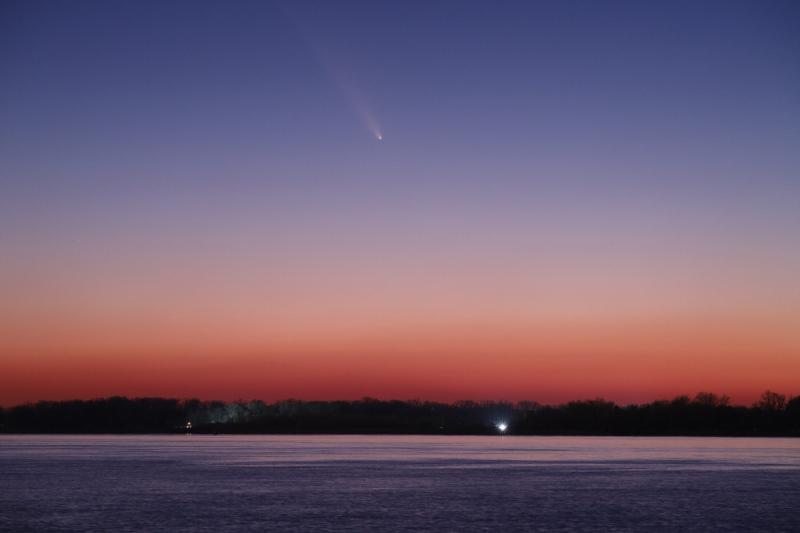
[0,391,800,436]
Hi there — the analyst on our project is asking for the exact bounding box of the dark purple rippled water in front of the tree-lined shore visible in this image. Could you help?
[0,436,800,532]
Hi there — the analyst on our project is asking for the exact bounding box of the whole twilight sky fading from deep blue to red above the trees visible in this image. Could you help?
[0,0,800,405]
